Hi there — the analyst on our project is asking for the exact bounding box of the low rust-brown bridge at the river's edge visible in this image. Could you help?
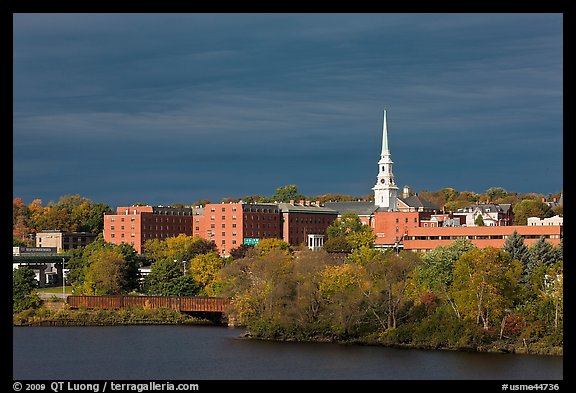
[67,295,230,313]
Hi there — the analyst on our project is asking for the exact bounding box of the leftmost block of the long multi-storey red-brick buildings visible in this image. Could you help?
[104,206,193,254]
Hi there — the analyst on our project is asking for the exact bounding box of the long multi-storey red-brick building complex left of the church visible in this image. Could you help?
[104,201,338,256]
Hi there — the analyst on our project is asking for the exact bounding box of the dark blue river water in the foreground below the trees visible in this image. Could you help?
[13,326,563,381]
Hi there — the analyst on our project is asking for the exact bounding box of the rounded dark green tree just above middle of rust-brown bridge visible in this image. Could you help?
[143,258,200,296]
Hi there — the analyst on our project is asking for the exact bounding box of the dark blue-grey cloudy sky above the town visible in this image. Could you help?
[12,13,563,208]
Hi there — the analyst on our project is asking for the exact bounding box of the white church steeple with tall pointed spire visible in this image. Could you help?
[372,110,398,211]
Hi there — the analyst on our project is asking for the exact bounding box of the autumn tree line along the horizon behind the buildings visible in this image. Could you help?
[12,184,563,246]
